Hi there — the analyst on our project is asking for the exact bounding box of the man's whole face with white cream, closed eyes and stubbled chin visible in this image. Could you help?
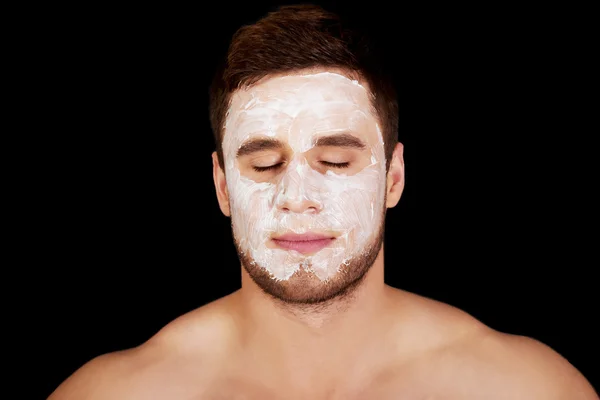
[223,72,386,302]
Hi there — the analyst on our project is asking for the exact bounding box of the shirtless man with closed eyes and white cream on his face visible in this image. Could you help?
[50,6,598,400]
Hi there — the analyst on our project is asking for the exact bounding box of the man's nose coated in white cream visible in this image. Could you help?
[276,162,323,214]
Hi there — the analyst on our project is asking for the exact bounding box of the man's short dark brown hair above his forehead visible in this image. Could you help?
[209,4,398,168]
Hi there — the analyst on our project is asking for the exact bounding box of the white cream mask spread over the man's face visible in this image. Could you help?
[223,72,386,280]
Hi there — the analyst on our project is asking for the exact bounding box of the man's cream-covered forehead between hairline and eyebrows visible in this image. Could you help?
[223,72,380,151]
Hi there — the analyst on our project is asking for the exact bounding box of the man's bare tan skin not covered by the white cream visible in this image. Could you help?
[49,71,598,400]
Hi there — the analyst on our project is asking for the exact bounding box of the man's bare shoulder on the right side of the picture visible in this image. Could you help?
[394,293,599,400]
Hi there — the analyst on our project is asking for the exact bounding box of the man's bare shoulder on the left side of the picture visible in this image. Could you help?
[48,290,239,400]
